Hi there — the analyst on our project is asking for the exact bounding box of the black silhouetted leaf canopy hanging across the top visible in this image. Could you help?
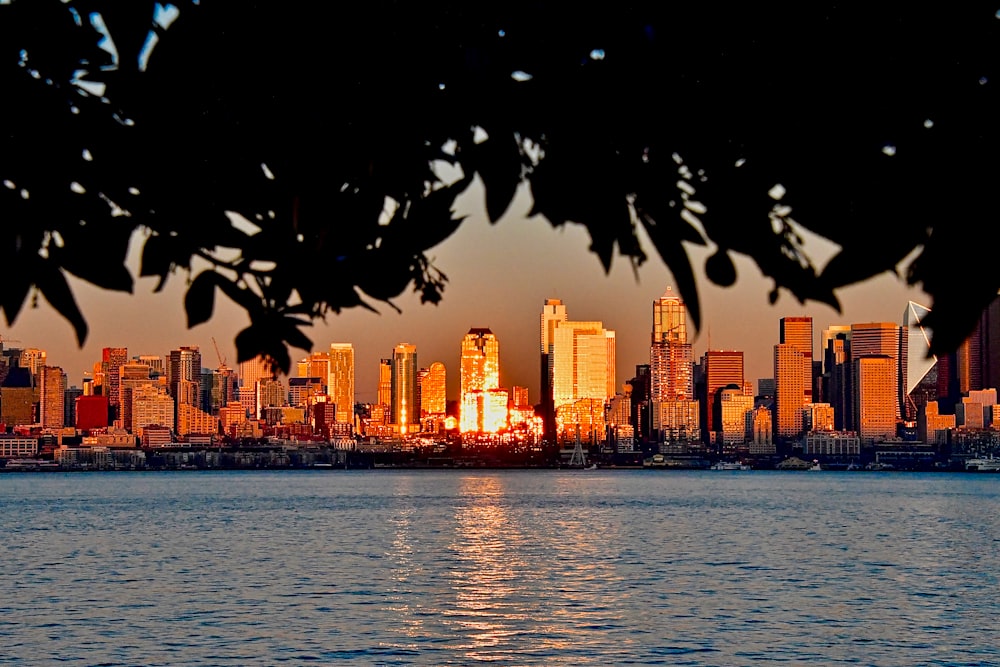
[0,0,1000,370]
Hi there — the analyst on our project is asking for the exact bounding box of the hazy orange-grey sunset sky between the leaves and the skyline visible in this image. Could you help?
[0,180,929,402]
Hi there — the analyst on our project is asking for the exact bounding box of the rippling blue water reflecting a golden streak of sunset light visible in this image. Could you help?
[0,470,1000,666]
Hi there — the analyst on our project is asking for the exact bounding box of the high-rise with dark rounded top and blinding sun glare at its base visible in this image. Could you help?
[459,328,507,433]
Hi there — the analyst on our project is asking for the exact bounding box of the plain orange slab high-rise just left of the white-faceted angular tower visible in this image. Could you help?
[851,354,899,443]
